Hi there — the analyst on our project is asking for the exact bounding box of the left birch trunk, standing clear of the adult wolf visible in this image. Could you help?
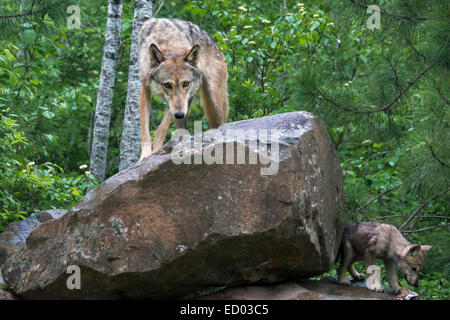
[90,0,123,181]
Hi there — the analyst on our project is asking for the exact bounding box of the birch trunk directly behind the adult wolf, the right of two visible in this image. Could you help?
[119,0,155,170]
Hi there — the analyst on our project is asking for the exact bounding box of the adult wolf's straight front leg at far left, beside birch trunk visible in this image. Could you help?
[139,83,152,161]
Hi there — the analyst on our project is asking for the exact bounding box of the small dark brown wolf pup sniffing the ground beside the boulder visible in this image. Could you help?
[338,222,432,294]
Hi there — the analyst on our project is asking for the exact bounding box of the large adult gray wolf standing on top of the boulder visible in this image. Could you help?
[139,19,229,160]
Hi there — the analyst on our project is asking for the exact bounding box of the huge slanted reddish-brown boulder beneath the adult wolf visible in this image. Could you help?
[2,112,344,299]
